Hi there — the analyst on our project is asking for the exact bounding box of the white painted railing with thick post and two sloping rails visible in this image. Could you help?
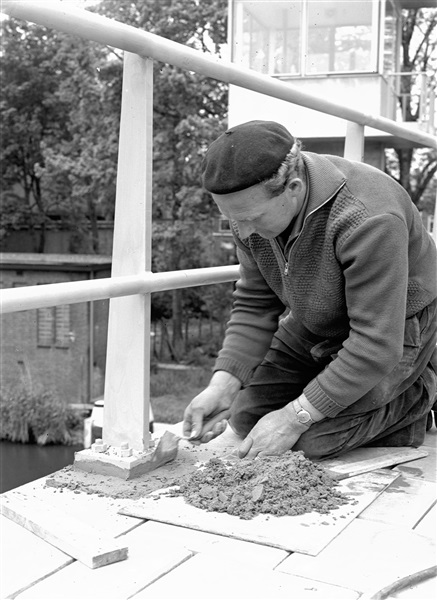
[1,0,437,450]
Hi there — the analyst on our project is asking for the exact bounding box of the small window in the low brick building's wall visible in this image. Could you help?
[37,304,70,348]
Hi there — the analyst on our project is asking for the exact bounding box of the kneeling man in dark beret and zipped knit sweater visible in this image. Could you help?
[184,121,437,458]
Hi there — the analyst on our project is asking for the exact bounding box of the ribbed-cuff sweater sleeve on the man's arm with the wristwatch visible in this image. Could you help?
[304,214,408,417]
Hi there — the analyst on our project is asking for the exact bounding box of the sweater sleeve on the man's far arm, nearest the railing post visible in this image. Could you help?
[214,241,285,385]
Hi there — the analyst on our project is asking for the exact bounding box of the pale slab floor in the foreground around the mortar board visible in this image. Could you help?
[0,428,437,600]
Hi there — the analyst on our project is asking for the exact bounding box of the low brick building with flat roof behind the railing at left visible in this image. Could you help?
[0,269,109,402]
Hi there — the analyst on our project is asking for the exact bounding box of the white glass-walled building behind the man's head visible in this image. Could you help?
[229,0,427,166]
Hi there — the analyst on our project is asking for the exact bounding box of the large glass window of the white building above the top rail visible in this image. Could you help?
[233,0,379,75]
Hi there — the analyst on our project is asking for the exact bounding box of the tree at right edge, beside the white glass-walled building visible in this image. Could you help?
[386,9,437,208]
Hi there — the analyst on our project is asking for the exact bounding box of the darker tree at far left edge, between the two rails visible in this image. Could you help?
[0,19,68,248]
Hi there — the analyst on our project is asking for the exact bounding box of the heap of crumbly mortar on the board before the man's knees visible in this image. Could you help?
[170,451,349,519]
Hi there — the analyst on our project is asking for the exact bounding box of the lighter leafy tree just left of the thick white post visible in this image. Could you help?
[41,36,122,253]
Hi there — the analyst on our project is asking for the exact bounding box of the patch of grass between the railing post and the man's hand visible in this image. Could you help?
[150,367,211,423]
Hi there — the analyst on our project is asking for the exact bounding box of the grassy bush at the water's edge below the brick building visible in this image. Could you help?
[0,388,78,445]
